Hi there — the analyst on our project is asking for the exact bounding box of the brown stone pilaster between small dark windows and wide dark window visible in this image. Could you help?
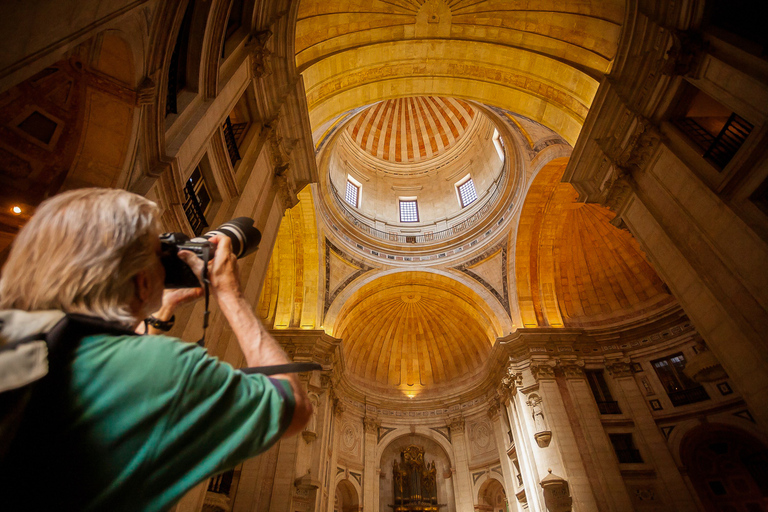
[605,360,698,512]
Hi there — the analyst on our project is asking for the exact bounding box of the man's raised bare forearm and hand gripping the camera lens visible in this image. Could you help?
[179,236,312,436]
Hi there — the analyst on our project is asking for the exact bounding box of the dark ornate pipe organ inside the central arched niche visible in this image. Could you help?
[390,445,446,512]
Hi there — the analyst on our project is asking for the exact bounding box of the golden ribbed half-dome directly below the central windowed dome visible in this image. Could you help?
[334,272,494,394]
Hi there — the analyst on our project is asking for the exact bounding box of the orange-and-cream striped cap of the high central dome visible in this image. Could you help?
[347,96,475,163]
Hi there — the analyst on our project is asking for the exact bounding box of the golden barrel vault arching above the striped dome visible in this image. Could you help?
[295,0,625,144]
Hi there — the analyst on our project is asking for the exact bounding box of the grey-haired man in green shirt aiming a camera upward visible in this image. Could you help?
[0,189,312,511]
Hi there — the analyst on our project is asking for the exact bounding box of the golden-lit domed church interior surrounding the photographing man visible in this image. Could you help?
[0,0,768,512]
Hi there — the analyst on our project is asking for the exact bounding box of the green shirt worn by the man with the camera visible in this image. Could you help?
[0,335,294,511]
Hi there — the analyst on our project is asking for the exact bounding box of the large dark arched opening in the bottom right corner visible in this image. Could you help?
[680,425,768,512]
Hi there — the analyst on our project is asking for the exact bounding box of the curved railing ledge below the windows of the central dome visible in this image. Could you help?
[331,173,506,244]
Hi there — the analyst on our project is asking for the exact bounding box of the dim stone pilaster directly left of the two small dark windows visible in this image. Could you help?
[562,362,632,512]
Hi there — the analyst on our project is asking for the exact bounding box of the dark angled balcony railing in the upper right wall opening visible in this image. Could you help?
[675,114,754,169]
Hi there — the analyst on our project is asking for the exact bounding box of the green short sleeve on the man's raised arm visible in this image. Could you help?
[136,345,295,508]
